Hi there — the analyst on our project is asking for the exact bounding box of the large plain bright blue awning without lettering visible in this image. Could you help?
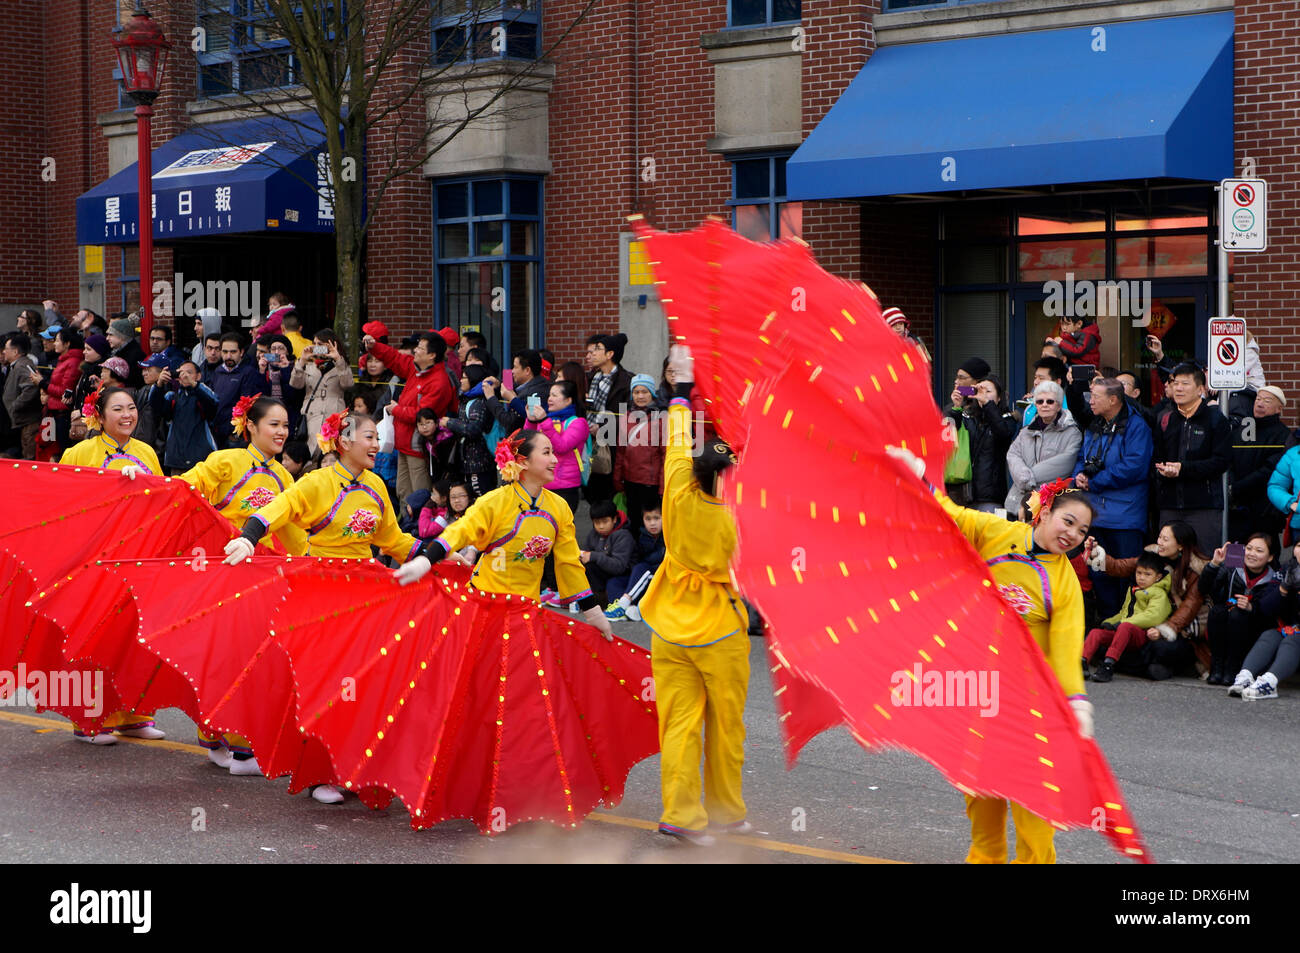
[787,13,1232,200]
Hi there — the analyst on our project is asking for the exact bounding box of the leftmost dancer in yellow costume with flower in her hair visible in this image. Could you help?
[59,387,165,745]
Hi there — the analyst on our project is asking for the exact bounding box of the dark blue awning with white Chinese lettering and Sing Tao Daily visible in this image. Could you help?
[77,113,334,244]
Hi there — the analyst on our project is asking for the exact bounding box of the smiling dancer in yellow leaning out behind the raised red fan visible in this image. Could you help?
[889,447,1096,863]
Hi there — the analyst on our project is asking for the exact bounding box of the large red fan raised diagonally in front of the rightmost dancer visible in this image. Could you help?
[641,219,1148,859]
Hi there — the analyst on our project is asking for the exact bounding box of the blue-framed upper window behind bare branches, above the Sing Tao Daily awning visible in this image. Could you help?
[196,0,330,96]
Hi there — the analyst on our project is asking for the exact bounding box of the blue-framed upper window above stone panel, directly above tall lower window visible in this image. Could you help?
[432,0,542,64]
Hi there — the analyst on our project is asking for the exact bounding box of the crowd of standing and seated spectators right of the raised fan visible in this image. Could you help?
[945,320,1300,699]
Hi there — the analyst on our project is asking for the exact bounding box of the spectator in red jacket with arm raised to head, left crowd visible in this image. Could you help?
[361,332,459,501]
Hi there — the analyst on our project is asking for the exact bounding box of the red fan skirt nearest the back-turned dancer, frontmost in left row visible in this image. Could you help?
[261,560,659,833]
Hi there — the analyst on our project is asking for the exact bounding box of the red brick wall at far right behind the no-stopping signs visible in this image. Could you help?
[1231,0,1300,400]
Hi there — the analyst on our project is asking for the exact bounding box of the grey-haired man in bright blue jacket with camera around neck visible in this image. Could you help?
[1074,377,1153,616]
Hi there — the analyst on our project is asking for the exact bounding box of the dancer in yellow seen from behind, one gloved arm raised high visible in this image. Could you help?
[631,347,754,846]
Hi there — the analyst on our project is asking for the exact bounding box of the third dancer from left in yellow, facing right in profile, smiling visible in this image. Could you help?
[225,412,441,803]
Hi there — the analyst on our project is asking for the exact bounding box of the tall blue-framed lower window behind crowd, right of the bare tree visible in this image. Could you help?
[433,178,542,367]
